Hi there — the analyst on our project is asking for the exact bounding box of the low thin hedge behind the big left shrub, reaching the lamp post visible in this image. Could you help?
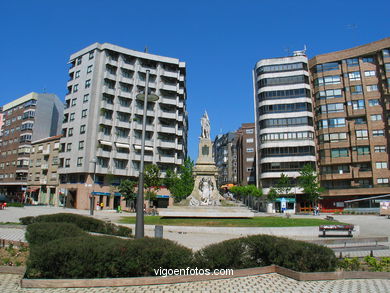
[20,213,132,237]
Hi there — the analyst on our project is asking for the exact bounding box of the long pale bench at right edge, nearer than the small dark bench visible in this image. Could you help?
[309,236,389,258]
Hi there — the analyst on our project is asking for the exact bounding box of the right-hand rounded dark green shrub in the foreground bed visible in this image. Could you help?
[195,235,336,272]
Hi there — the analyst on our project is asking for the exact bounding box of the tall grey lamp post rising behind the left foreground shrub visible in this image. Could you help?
[135,70,158,238]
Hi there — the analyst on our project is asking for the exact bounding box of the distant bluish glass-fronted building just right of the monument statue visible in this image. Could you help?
[213,132,237,186]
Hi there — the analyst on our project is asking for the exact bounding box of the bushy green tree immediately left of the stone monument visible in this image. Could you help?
[163,158,194,202]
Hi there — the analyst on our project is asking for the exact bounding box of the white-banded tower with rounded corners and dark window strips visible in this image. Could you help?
[253,51,316,203]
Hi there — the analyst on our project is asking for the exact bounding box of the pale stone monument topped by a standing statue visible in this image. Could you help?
[188,111,223,206]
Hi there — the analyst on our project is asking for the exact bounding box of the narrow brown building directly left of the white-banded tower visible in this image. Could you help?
[235,123,256,185]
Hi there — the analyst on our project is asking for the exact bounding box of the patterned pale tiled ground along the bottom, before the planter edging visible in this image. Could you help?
[0,274,390,293]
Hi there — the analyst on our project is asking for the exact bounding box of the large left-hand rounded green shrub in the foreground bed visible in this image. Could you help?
[26,236,192,279]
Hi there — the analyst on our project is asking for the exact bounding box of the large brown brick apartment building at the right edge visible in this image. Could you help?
[309,38,390,209]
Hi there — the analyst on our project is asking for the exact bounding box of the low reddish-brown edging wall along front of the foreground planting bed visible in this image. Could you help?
[21,265,390,288]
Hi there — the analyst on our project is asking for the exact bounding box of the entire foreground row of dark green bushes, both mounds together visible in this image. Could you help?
[26,222,336,278]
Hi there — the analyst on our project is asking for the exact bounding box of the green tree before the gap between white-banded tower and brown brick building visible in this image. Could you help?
[298,164,324,205]
